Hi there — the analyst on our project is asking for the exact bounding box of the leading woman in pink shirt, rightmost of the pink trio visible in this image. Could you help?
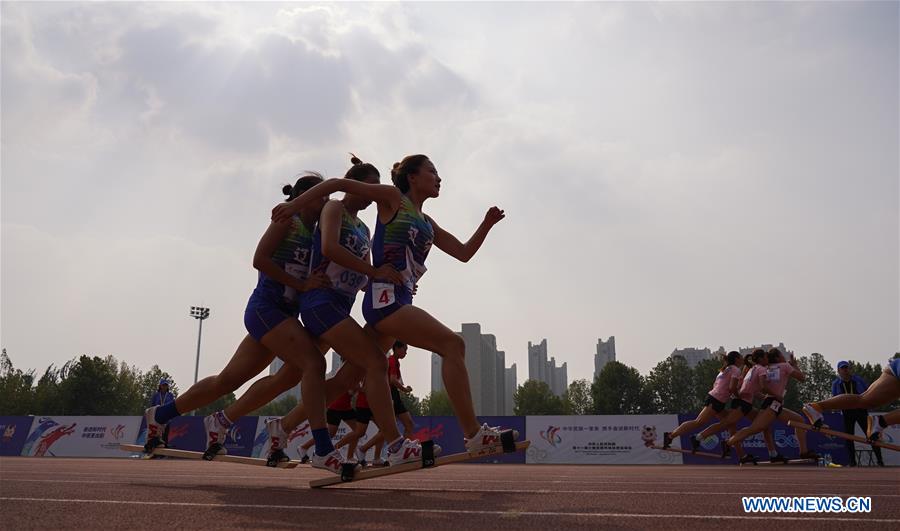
[722,348,818,459]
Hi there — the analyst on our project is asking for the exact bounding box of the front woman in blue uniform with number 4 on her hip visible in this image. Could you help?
[272,155,504,451]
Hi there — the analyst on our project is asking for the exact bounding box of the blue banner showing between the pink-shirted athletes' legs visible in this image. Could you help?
[673,413,849,465]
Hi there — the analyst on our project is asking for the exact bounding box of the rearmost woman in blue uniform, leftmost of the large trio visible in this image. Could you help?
[145,174,338,474]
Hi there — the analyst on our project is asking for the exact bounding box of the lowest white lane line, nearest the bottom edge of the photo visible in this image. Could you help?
[0,496,900,523]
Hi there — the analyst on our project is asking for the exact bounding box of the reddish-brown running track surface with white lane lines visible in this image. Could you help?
[0,458,900,530]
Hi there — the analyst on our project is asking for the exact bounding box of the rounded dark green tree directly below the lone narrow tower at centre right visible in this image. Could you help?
[591,361,651,415]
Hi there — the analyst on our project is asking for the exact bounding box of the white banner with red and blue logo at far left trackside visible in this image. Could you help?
[21,416,141,457]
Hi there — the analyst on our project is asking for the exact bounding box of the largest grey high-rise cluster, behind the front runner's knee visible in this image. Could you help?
[431,323,515,415]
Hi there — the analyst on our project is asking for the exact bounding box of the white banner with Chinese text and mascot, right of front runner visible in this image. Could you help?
[525,415,682,465]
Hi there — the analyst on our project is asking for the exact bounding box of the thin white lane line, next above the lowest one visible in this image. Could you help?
[4,478,900,498]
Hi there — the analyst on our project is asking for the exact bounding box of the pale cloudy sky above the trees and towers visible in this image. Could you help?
[0,2,900,400]
